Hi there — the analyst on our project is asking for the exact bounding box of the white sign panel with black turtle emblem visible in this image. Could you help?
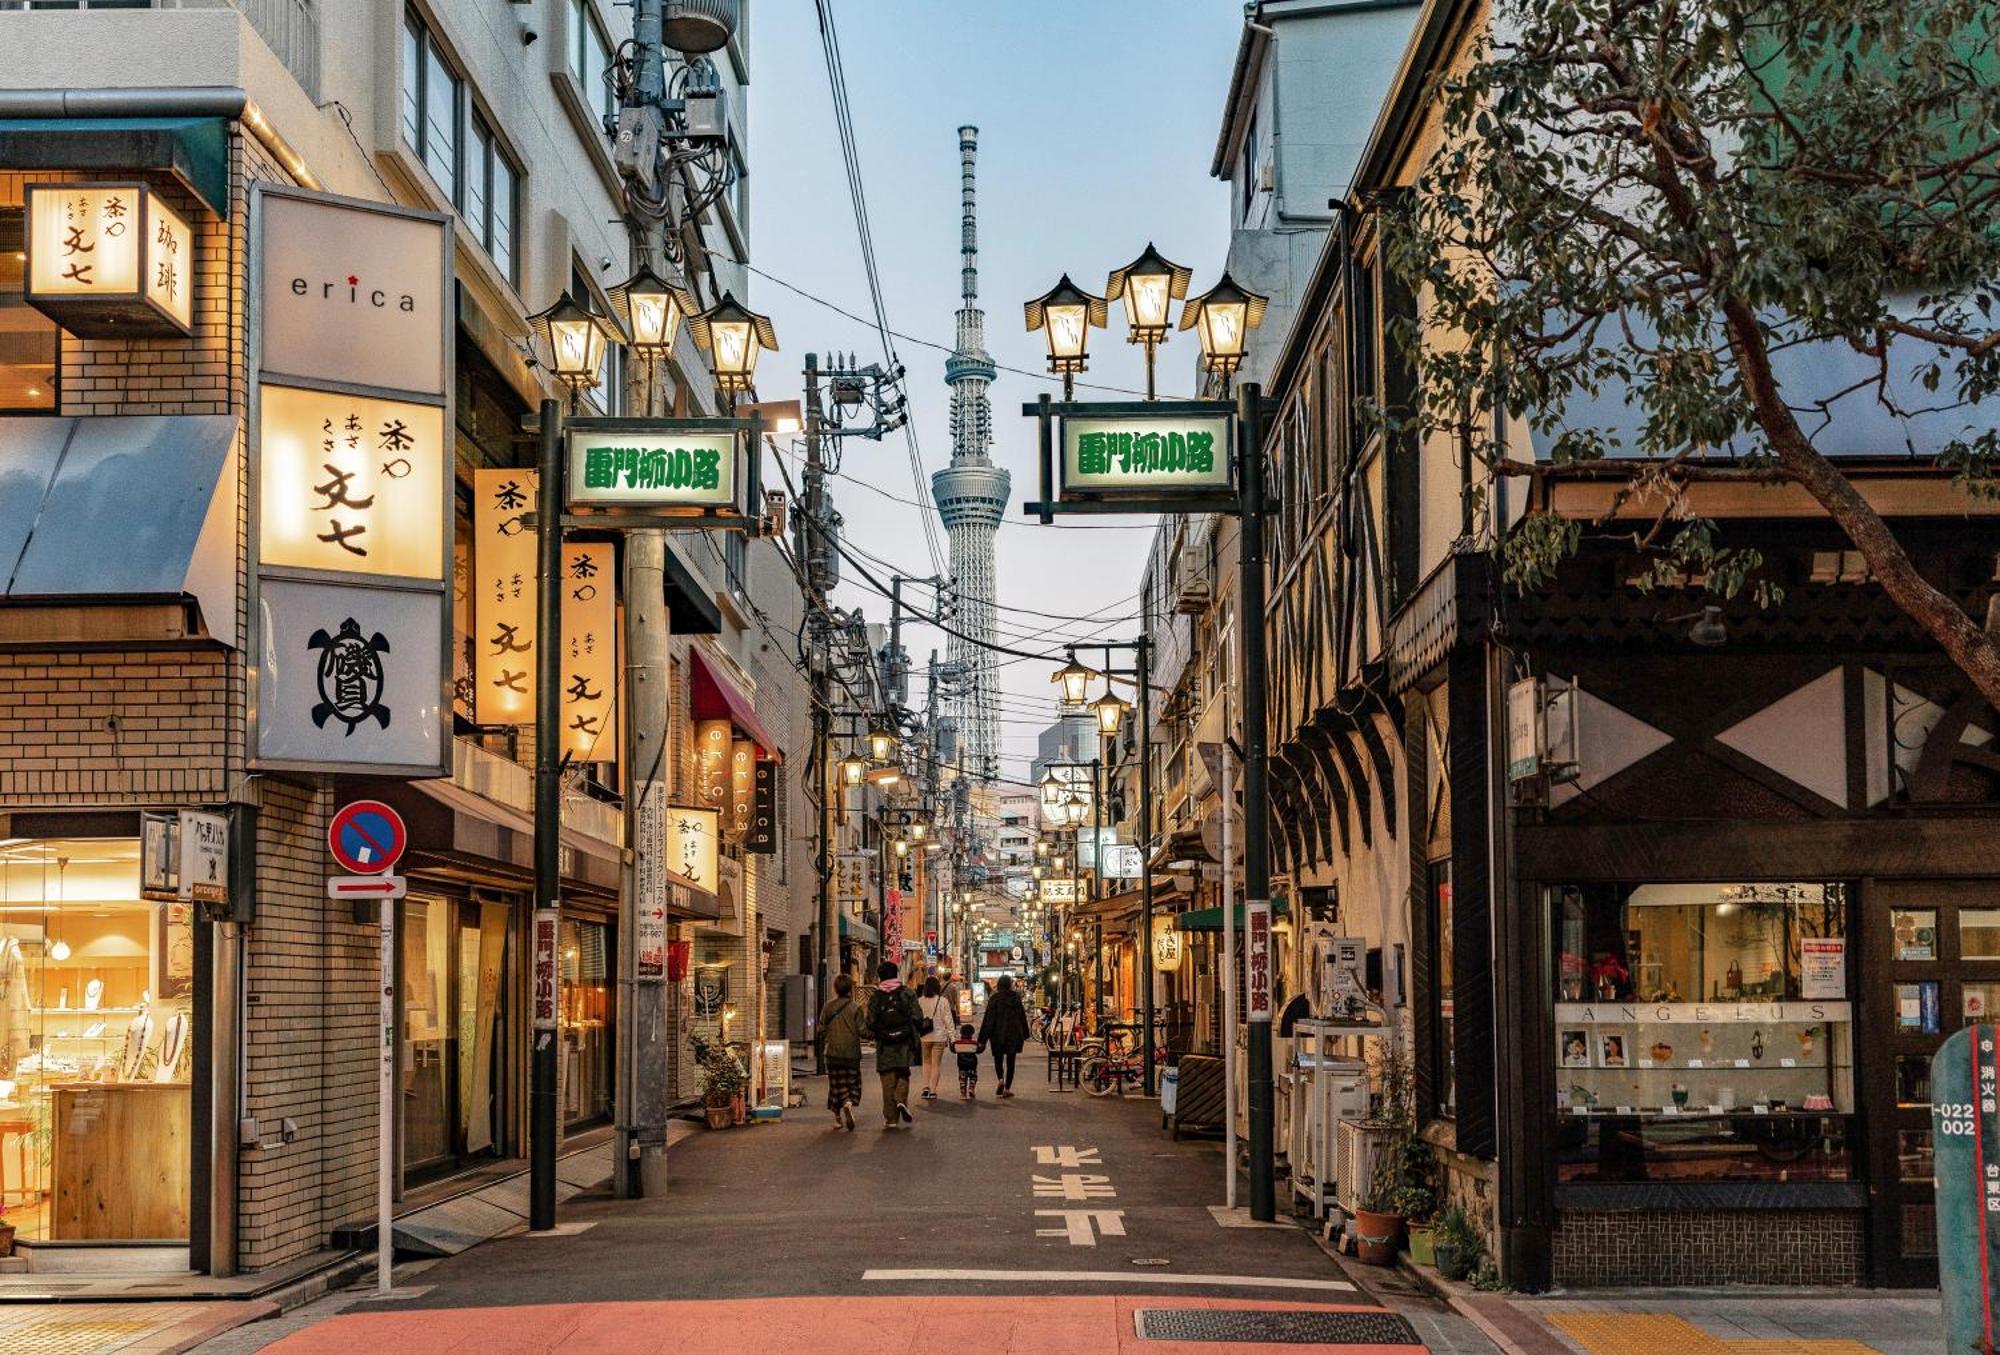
[256,580,450,775]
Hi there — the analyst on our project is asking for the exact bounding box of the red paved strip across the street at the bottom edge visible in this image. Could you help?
[266,1295,1424,1355]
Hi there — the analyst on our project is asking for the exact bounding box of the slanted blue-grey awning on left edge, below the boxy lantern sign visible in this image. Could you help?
[0,414,238,646]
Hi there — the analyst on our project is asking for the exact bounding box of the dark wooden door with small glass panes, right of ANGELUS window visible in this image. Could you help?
[1862,881,2000,1287]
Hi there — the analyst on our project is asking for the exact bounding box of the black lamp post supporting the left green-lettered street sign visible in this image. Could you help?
[528,400,562,1233]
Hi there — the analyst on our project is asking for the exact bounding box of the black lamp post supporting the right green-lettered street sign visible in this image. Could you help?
[1224,382,1278,1223]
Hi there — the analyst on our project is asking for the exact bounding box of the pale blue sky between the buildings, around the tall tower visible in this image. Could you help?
[750,0,1242,775]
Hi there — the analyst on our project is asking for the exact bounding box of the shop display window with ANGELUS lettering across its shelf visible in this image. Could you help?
[1550,883,1856,1181]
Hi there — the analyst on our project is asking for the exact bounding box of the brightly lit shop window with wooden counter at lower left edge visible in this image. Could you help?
[0,837,194,1241]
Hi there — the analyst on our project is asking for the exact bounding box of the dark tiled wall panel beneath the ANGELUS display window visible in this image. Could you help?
[1554,1209,1866,1287]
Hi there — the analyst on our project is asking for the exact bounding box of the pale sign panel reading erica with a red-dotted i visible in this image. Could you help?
[256,190,452,396]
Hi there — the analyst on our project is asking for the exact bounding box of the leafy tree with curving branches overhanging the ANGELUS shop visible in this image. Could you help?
[1384,0,2000,707]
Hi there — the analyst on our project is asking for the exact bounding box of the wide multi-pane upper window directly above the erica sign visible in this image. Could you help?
[402,14,520,282]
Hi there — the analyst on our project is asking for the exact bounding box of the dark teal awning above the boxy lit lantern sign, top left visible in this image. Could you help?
[0,118,230,218]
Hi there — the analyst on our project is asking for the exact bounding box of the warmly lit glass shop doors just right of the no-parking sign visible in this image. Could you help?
[400,893,508,1183]
